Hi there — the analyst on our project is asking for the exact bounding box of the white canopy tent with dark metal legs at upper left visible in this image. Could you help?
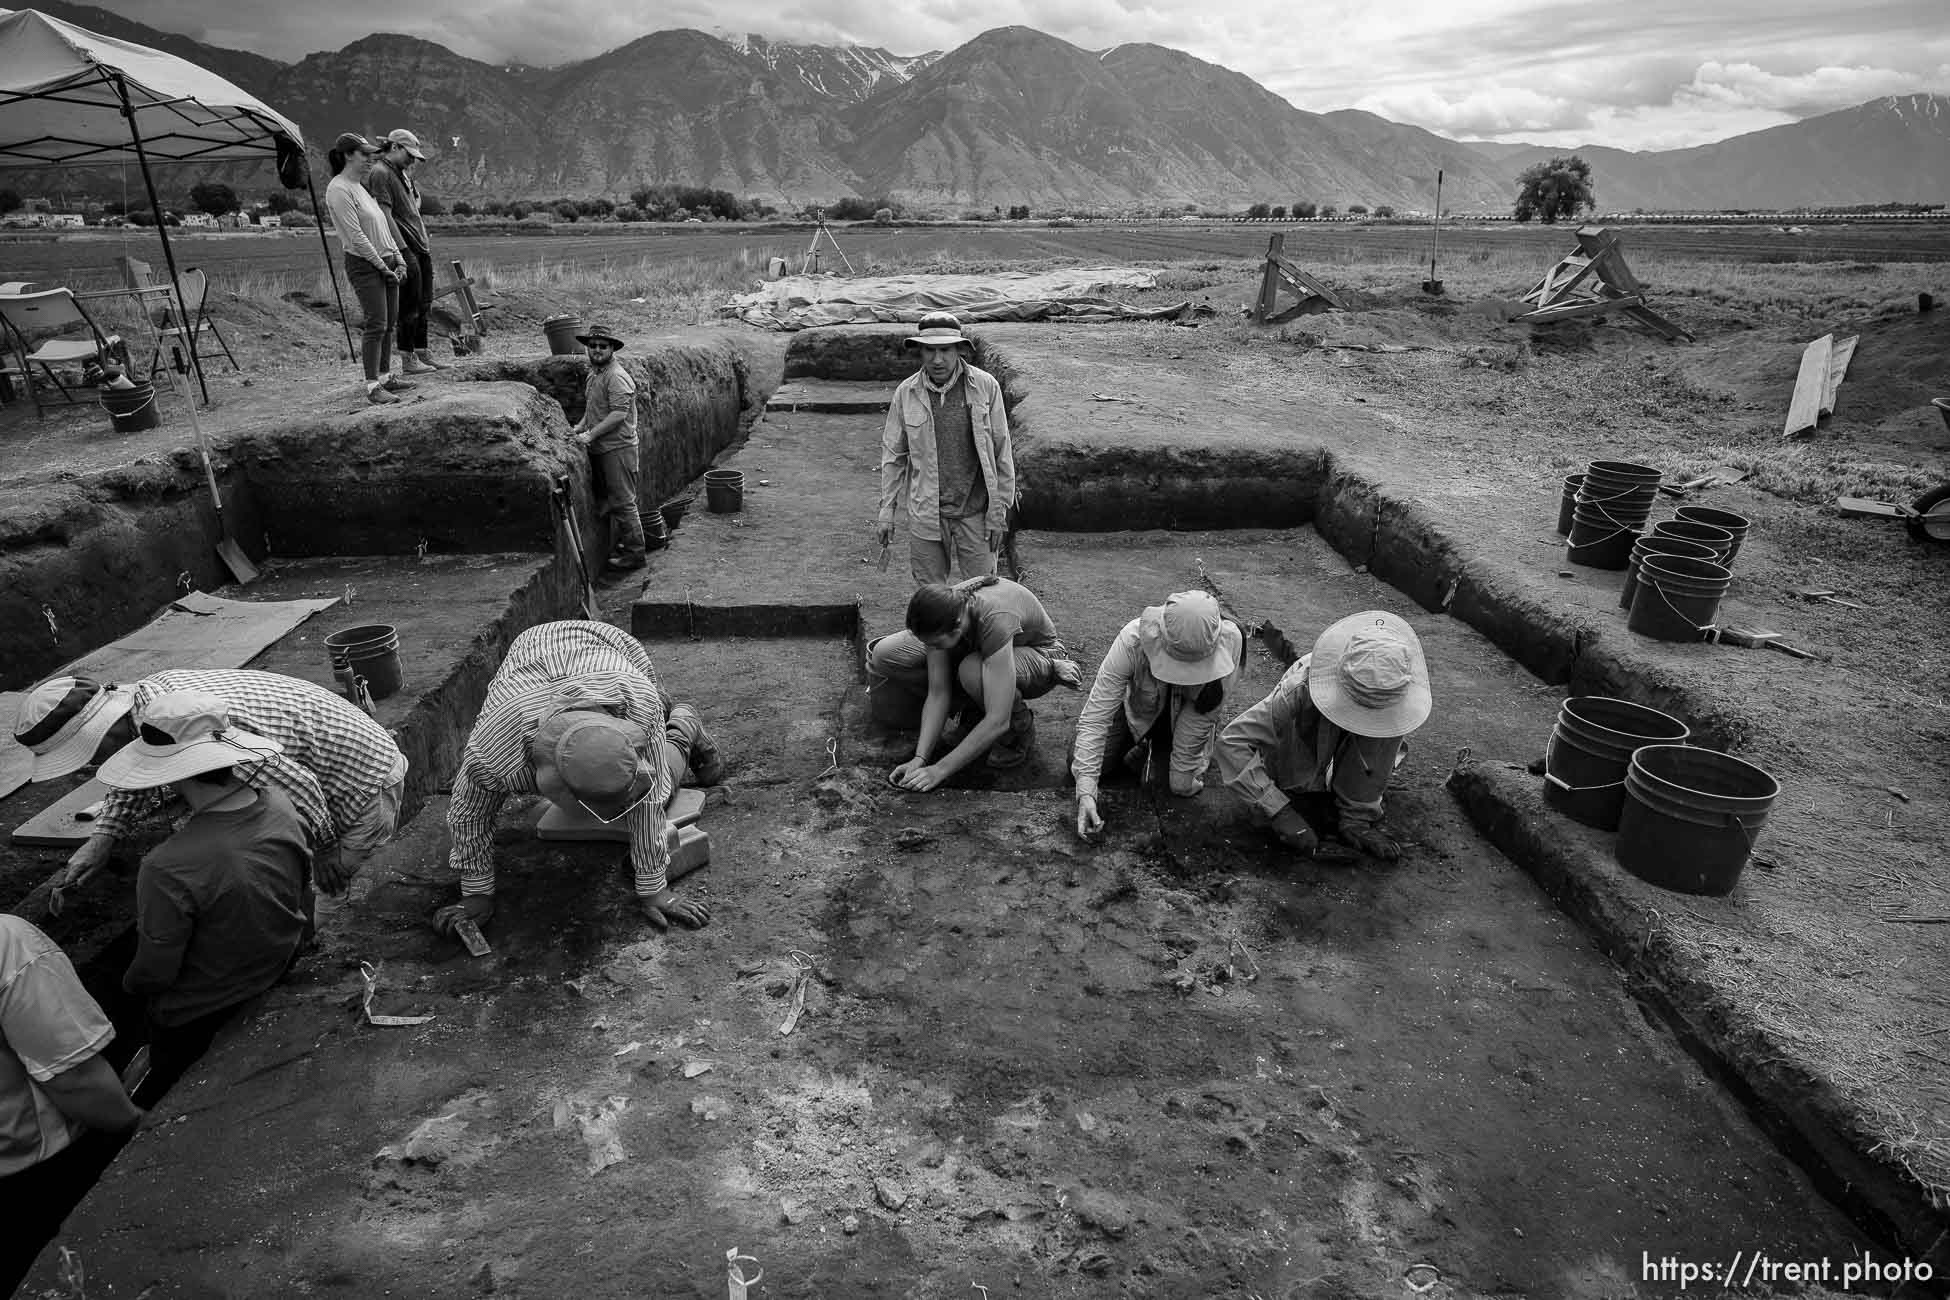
[0,10,351,393]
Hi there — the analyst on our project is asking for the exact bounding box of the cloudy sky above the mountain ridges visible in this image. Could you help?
[96,0,1950,148]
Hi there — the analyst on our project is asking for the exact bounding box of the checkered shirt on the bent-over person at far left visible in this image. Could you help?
[96,669,406,844]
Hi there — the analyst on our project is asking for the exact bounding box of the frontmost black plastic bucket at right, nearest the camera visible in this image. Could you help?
[1615,745,1780,895]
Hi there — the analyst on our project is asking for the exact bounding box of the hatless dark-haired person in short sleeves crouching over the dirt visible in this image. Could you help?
[868,575,1082,791]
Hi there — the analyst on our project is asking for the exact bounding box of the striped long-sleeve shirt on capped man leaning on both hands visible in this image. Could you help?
[447,620,671,895]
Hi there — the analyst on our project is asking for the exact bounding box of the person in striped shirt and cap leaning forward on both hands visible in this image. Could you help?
[433,620,723,934]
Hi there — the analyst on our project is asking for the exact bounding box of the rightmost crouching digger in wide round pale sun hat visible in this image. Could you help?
[1219,610,1431,861]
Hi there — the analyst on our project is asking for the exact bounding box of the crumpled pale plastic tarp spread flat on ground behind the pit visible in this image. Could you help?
[720,267,1191,329]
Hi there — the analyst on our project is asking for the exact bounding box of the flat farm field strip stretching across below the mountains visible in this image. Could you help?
[0,222,1950,298]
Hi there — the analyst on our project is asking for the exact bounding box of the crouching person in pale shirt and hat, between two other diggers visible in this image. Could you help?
[1071,591,1244,838]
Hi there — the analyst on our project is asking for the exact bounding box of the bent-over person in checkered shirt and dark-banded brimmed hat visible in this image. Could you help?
[14,669,408,910]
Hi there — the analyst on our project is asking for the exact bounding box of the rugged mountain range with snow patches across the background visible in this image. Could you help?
[15,0,1950,212]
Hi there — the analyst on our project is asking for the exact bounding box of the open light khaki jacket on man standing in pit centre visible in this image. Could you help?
[878,363,1016,542]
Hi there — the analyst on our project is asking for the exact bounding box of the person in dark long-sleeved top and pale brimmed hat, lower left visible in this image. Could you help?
[96,690,312,1105]
